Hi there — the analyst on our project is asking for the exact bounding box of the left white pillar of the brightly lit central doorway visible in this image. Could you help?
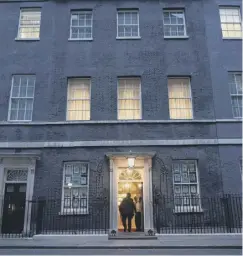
[109,159,118,235]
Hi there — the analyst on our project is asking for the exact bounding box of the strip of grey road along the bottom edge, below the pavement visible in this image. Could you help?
[0,248,242,256]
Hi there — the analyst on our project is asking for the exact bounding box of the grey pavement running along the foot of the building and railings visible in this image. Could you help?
[0,233,242,249]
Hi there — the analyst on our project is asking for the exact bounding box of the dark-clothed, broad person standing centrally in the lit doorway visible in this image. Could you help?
[119,193,136,232]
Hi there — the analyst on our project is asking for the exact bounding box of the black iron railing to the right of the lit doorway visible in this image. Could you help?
[153,195,242,234]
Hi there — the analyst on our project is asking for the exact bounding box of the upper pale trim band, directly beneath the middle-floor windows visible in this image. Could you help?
[0,118,243,126]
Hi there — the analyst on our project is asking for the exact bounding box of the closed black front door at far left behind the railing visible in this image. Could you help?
[2,183,26,234]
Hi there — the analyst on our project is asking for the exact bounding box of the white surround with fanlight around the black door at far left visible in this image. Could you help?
[0,153,39,234]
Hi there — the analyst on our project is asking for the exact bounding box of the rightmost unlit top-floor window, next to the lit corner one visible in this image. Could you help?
[164,10,187,37]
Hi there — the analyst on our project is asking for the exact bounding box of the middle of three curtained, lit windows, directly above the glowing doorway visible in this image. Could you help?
[118,77,141,120]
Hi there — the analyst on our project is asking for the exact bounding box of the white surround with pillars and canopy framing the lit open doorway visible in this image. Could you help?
[106,152,155,235]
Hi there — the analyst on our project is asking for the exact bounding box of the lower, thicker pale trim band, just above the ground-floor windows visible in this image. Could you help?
[0,138,242,149]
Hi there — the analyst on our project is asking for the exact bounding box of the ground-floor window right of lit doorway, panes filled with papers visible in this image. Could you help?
[172,160,200,211]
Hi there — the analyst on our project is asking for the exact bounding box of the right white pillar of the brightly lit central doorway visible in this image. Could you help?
[144,158,154,235]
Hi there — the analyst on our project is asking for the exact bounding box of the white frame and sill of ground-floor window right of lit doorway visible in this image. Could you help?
[172,159,203,213]
